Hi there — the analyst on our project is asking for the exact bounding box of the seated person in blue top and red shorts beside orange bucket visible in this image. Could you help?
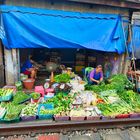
[21,55,40,78]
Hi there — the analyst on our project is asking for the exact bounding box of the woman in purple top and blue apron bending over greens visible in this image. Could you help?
[89,65,103,85]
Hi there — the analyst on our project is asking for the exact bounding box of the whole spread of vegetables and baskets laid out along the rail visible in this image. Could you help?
[0,73,140,122]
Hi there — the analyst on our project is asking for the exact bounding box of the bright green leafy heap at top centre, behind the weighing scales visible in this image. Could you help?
[54,73,71,83]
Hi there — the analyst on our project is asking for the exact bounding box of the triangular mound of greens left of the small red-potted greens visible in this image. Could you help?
[12,91,31,105]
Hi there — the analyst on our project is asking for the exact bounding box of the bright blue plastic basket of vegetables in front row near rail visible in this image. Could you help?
[37,104,54,119]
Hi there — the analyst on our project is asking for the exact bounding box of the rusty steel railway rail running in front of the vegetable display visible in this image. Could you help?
[0,118,140,136]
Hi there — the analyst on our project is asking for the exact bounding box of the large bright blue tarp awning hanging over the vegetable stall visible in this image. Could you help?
[0,5,125,54]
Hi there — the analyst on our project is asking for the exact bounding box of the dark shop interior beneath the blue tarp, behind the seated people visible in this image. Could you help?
[20,48,117,84]
